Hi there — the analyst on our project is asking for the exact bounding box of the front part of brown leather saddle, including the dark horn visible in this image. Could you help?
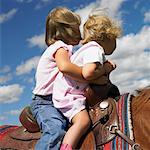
[85,83,120,146]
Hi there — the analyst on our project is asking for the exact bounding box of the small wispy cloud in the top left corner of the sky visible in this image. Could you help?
[0,8,17,24]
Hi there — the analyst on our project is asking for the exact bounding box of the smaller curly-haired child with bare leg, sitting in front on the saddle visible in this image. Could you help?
[53,15,121,150]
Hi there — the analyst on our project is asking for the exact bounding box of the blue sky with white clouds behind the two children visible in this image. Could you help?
[0,0,150,125]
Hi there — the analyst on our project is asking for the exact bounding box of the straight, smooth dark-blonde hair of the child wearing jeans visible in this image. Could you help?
[45,7,81,46]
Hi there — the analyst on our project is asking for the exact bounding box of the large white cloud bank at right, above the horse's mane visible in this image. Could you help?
[110,26,150,93]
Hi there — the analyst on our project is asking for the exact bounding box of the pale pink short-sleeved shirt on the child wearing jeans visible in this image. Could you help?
[33,41,72,95]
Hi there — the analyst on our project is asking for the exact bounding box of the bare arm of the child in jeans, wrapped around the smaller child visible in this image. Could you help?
[54,48,87,82]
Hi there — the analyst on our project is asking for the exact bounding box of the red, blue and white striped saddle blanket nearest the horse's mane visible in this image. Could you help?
[103,94,133,150]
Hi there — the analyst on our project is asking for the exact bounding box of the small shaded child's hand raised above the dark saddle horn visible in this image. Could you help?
[104,60,116,74]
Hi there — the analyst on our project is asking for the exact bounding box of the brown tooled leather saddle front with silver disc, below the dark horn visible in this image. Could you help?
[89,98,119,146]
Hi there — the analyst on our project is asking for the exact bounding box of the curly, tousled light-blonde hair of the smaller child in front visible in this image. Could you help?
[82,15,121,44]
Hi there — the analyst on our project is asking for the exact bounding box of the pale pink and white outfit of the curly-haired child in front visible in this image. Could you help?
[53,41,105,120]
